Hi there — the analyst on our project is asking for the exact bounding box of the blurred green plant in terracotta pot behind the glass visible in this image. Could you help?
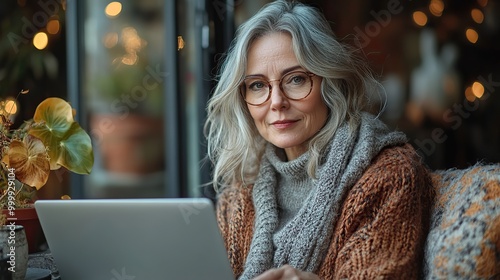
[89,64,164,175]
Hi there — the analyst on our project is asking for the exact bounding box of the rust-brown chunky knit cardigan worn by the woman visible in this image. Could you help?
[217,144,432,280]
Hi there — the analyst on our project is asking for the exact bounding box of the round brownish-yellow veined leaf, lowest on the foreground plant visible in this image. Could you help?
[7,135,50,190]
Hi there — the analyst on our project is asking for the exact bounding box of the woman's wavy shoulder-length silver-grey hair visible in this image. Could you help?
[205,0,380,188]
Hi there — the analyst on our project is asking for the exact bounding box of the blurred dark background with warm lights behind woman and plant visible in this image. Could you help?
[0,0,500,198]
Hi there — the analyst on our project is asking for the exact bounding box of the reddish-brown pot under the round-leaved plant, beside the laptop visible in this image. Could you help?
[2,207,45,254]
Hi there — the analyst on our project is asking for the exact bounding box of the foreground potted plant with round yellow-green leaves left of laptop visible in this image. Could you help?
[0,91,94,252]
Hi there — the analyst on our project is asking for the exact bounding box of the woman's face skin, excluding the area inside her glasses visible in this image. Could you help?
[246,33,328,160]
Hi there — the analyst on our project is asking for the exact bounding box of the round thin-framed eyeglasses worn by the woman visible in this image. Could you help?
[240,71,314,106]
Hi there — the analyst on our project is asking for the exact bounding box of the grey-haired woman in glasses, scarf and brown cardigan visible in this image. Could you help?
[206,1,430,280]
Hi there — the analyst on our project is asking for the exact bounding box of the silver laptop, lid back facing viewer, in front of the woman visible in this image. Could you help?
[35,198,234,280]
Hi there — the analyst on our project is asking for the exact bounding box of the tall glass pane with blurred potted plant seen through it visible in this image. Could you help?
[80,0,167,197]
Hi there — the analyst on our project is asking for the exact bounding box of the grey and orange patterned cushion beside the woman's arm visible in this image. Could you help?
[424,164,500,279]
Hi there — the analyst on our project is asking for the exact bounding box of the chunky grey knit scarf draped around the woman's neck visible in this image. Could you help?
[240,113,406,279]
